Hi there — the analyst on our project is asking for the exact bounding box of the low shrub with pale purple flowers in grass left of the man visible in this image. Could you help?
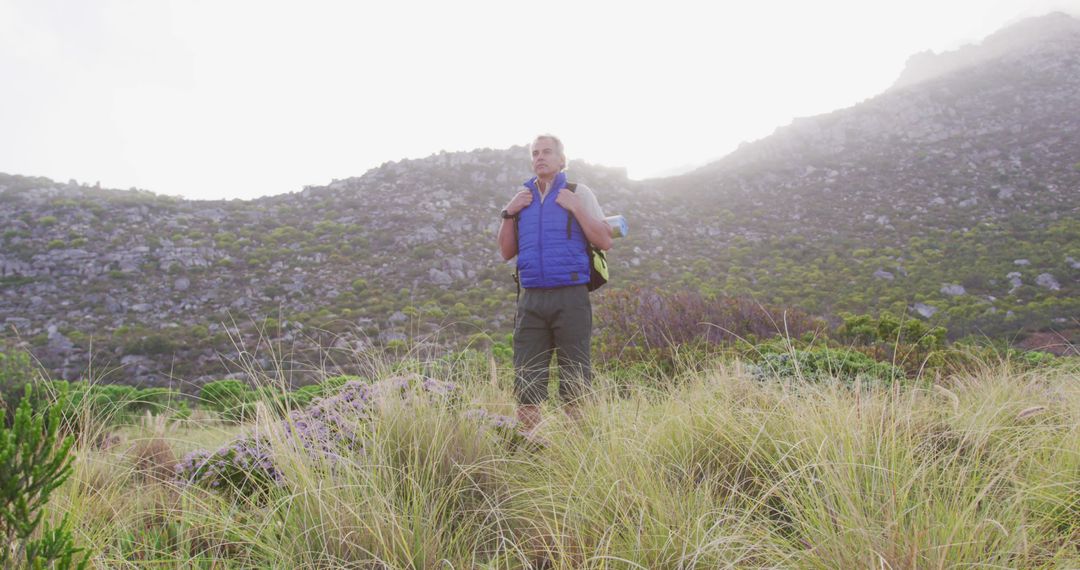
[176,376,459,496]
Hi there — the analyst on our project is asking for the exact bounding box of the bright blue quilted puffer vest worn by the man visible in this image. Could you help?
[517,173,589,289]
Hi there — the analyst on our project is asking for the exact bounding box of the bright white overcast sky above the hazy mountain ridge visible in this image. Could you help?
[0,0,1080,199]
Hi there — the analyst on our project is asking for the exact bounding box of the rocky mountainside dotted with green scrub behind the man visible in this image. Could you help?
[0,14,1080,384]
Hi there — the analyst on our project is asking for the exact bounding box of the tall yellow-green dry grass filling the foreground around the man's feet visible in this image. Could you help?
[48,354,1080,569]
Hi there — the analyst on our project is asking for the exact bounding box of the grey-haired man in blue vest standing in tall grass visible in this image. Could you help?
[499,135,611,438]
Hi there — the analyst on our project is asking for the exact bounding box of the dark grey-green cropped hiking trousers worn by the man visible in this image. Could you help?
[514,285,593,405]
